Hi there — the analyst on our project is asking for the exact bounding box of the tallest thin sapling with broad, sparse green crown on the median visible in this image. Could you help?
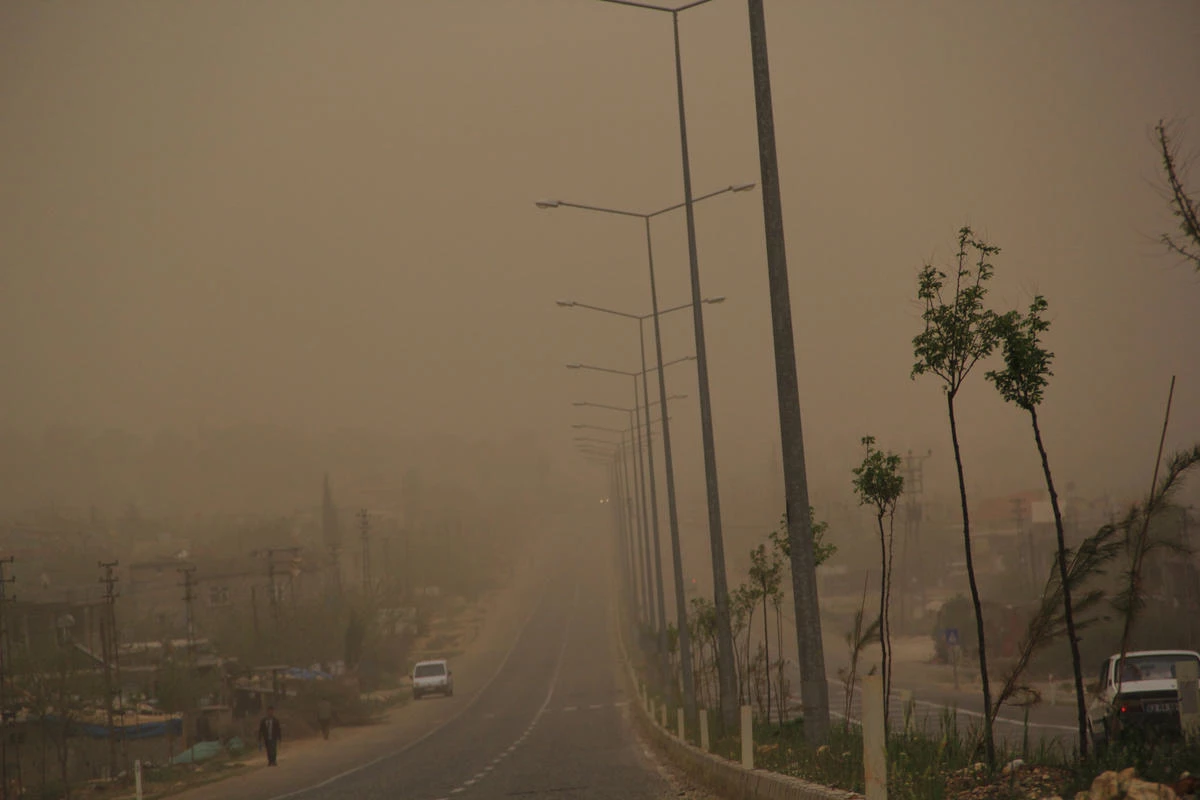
[912,227,1003,764]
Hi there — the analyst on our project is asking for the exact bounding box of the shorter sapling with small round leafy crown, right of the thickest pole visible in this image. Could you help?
[853,437,904,729]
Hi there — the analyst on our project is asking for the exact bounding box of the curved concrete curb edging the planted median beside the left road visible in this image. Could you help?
[618,633,863,800]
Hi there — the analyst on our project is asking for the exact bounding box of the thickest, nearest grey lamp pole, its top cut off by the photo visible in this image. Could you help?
[748,0,829,744]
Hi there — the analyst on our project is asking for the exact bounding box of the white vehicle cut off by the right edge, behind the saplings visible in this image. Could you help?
[1088,650,1200,745]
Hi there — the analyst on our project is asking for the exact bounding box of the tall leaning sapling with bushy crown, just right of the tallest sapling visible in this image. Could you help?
[986,295,1087,758]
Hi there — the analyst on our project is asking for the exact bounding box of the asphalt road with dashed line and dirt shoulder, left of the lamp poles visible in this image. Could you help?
[188,561,677,800]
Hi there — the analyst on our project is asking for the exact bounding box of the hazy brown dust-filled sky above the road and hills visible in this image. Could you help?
[0,0,1200,513]
